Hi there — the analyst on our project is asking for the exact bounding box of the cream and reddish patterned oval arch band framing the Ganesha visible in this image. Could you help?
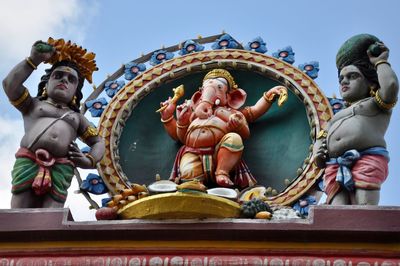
[98,49,333,205]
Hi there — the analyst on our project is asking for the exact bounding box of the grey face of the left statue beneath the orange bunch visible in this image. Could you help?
[46,66,79,104]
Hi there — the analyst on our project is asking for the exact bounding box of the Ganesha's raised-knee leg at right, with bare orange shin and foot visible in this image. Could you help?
[215,133,243,187]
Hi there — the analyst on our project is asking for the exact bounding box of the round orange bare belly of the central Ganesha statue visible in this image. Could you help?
[186,116,228,148]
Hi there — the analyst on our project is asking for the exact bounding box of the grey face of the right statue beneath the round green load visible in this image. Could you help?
[339,65,370,102]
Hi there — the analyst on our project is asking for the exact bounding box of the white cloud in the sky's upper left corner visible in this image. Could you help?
[0,0,97,73]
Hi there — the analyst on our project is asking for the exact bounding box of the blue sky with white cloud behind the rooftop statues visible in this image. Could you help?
[0,0,400,220]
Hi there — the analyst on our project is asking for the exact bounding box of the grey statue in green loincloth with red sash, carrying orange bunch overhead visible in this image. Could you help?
[3,38,104,208]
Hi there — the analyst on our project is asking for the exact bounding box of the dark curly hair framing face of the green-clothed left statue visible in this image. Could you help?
[37,61,84,112]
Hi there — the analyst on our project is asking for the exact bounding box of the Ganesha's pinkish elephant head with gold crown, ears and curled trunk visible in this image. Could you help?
[192,69,247,119]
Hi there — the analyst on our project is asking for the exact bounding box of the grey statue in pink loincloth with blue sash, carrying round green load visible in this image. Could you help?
[315,34,399,205]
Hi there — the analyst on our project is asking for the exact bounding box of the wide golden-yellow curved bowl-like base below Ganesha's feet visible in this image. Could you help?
[118,192,240,219]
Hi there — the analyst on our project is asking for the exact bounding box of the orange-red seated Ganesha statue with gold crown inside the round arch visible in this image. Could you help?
[160,69,287,189]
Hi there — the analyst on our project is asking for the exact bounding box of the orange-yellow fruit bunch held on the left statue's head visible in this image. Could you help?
[47,37,99,83]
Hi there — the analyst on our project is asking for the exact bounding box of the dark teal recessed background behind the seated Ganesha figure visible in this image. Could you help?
[118,70,311,191]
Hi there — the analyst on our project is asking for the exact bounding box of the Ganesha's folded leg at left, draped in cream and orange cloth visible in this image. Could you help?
[179,152,204,182]
